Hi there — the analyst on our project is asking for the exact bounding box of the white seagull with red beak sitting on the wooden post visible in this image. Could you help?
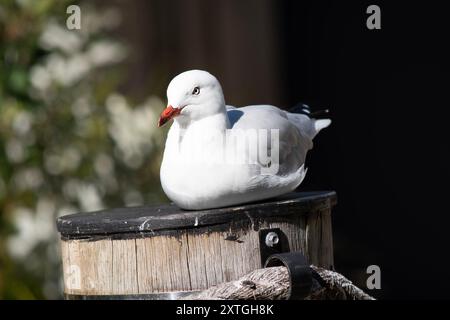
[158,70,331,210]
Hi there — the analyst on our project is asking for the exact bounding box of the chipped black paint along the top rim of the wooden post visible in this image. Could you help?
[57,191,336,241]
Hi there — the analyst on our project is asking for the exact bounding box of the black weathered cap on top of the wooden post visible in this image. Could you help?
[57,191,336,238]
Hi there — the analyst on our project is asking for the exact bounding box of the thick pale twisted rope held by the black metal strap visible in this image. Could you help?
[183,266,374,300]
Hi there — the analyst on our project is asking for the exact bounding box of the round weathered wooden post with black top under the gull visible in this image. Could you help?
[57,192,336,299]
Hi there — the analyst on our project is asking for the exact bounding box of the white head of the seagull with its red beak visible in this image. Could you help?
[158,70,226,127]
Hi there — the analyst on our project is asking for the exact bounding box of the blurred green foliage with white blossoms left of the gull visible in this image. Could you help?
[0,0,164,299]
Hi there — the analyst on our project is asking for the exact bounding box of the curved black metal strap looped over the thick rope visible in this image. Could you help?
[264,252,313,300]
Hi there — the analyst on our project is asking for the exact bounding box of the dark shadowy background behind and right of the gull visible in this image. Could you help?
[113,0,450,299]
